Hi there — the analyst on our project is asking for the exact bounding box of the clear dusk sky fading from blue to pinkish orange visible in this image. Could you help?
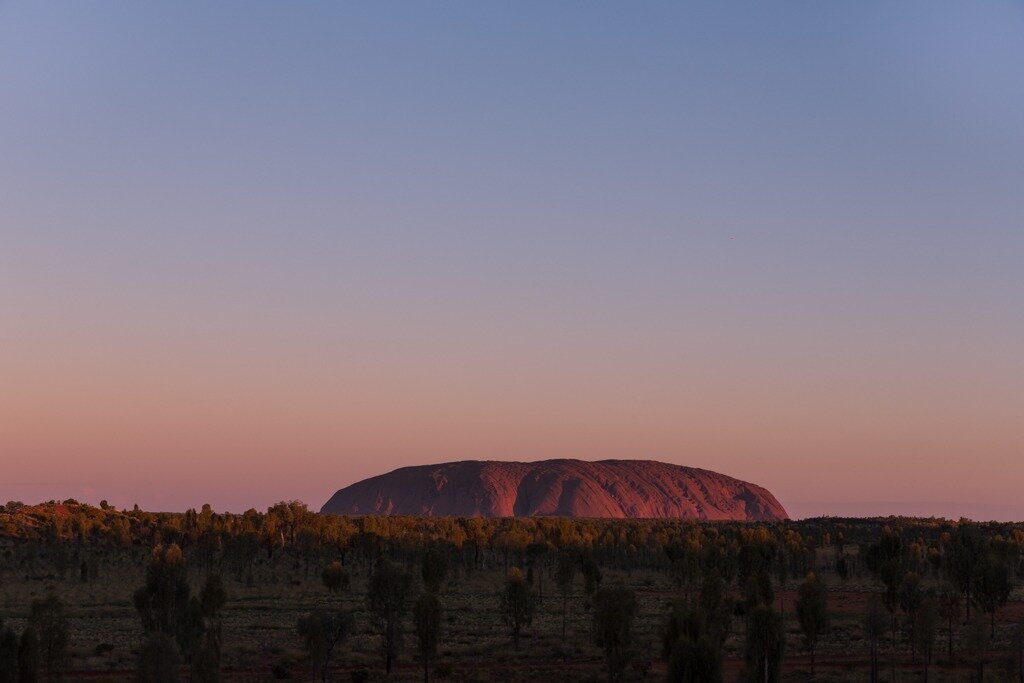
[0,0,1024,520]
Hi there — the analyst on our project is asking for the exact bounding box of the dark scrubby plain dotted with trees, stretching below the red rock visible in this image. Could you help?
[0,501,1024,683]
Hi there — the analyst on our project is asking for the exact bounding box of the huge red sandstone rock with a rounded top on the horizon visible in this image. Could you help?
[321,460,787,521]
